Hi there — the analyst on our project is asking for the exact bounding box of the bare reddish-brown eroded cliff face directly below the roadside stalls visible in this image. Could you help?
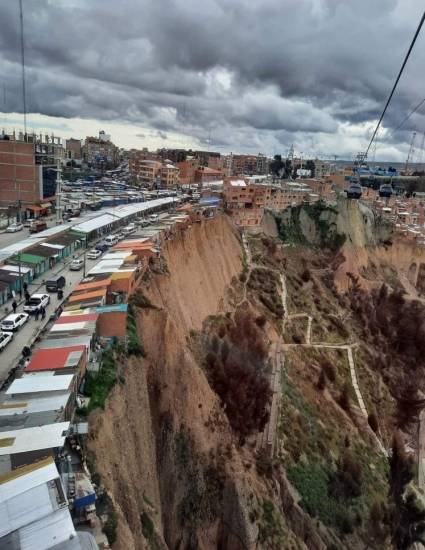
[89,217,264,550]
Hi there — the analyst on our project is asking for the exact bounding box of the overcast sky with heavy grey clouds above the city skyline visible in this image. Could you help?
[0,0,425,160]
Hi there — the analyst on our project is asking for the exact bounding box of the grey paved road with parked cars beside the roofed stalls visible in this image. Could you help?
[0,252,101,385]
